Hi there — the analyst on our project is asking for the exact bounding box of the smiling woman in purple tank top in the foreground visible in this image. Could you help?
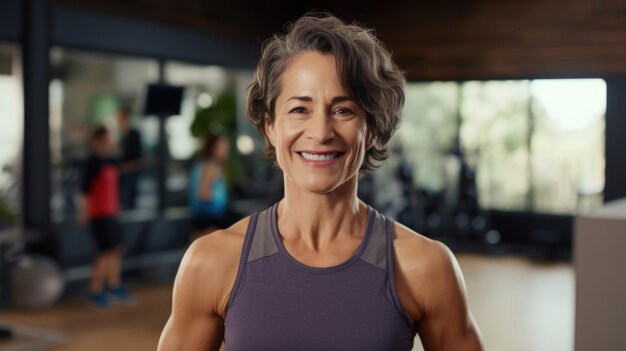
[160,15,482,351]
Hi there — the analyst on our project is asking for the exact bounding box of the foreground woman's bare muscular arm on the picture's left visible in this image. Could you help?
[158,231,237,351]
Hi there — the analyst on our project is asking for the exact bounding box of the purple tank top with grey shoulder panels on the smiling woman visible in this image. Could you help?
[224,204,416,351]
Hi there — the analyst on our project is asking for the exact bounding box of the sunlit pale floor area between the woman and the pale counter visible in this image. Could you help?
[413,255,575,351]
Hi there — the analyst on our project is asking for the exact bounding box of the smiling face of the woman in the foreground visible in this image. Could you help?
[265,52,369,193]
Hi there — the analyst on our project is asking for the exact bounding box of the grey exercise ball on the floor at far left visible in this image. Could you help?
[10,255,65,308]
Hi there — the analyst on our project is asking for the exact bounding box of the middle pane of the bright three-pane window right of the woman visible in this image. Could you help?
[460,81,530,210]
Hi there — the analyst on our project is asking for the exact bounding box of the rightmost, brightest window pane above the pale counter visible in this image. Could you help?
[531,79,606,213]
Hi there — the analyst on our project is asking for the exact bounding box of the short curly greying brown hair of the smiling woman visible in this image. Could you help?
[247,13,406,175]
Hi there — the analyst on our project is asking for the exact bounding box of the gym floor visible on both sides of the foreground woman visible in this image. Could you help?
[0,254,574,351]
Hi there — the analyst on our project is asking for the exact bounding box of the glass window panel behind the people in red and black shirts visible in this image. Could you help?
[50,47,158,223]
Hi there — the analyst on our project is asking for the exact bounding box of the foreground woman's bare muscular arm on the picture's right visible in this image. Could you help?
[394,223,483,351]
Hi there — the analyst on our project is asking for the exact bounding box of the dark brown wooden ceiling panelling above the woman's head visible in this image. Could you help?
[52,0,626,80]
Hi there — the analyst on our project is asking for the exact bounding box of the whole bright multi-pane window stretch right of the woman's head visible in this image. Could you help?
[395,79,606,214]
